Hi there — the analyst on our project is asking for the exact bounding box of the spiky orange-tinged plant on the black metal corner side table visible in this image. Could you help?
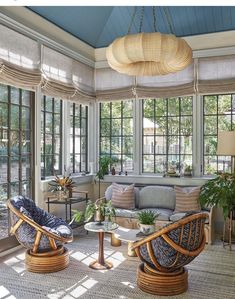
[48,175,75,200]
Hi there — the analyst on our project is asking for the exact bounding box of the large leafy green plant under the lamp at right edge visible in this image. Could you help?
[200,173,235,218]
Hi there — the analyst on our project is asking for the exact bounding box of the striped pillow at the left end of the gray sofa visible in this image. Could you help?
[111,183,135,209]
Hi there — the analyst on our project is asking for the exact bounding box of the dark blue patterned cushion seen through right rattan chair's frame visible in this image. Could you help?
[140,213,204,271]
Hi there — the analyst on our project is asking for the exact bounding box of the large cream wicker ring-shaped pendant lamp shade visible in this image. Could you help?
[106,32,192,76]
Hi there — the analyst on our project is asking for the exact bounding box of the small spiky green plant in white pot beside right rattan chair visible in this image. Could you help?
[138,210,159,235]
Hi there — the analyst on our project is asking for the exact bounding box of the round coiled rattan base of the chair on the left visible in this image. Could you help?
[25,248,69,273]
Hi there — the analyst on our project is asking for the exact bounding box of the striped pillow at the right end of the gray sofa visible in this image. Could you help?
[174,186,201,212]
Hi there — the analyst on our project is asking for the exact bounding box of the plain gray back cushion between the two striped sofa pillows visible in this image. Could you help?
[139,186,175,210]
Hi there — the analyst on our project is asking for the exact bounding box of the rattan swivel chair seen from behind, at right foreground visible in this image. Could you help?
[132,213,208,296]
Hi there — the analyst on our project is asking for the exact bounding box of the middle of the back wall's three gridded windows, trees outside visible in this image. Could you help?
[142,96,193,173]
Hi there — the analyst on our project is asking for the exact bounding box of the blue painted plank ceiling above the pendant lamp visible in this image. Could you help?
[28,6,235,48]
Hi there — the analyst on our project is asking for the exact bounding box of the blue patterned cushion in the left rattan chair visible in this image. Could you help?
[11,196,73,251]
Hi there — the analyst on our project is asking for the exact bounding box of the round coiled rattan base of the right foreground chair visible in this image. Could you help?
[137,263,188,296]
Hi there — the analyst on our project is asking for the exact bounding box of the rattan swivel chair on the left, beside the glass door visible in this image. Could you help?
[7,196,73,273]
